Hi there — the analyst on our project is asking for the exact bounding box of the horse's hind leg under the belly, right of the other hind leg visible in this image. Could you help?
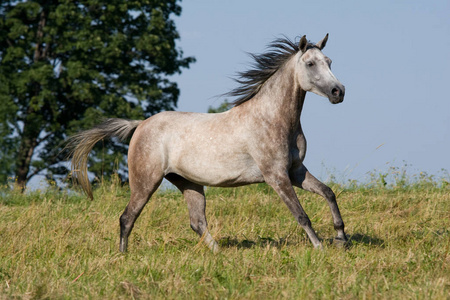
[166,174,219,253]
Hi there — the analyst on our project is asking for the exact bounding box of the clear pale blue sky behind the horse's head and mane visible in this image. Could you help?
[174,0,450,180]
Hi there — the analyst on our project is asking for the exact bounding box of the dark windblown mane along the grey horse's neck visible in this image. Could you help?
[229,37,315,106]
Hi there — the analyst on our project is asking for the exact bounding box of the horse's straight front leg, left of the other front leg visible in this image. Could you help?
[265,172,322,249]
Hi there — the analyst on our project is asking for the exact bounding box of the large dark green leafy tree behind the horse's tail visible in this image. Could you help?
[0,0,194,186]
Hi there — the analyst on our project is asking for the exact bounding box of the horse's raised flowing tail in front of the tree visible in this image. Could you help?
[66,119,142,200]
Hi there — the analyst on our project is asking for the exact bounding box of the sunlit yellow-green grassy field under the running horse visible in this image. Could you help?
[0,177,450,299]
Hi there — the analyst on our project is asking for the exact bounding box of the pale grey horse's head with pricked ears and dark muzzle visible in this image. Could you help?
[297,34,345,104]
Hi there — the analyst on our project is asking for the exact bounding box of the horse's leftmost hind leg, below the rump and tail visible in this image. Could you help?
[119,173,163,252]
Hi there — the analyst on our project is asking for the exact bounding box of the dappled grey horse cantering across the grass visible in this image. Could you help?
[67,34,348,252]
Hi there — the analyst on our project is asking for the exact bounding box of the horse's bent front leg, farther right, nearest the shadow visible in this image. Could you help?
[289,164,347,245]
